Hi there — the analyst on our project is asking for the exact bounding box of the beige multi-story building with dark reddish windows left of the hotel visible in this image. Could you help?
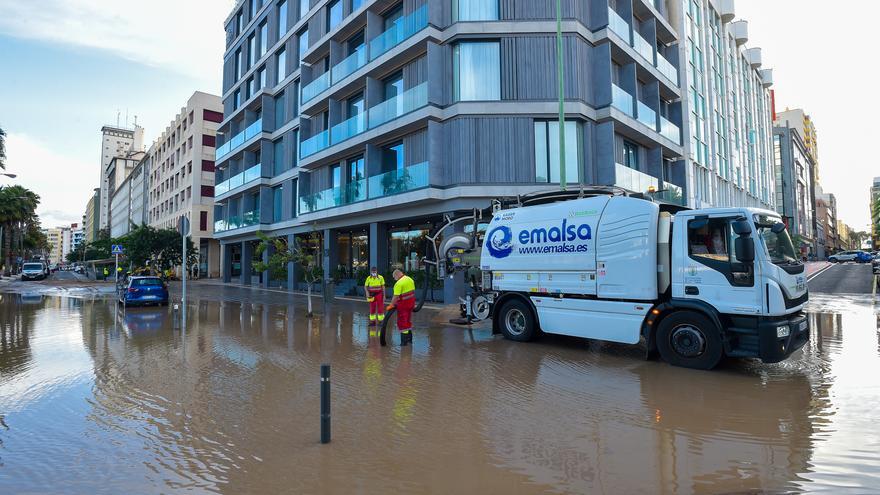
[147,91,223,277]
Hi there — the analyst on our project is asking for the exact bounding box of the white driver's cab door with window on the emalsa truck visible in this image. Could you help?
[674,216,761,315]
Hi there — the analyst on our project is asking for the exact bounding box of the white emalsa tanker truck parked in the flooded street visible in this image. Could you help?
[438,194,809,369]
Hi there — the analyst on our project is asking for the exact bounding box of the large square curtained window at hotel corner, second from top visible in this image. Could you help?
[453,42,501,101]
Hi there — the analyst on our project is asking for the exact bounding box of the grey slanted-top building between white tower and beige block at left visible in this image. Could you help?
[110,153,152,237]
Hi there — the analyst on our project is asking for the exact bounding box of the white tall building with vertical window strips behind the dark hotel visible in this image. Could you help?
[672,0,775,209]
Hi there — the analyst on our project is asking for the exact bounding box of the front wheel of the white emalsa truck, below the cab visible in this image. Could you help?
[657,311,724,370]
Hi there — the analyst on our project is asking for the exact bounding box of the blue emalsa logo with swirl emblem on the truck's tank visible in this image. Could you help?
[486,219,593,258]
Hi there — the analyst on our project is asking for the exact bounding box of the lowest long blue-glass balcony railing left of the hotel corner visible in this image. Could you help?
[299,162,428,215]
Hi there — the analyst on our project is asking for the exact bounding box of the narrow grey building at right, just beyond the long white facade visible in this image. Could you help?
[773,127,817,257]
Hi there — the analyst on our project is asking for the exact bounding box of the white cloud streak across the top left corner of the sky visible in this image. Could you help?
[0,0,234,79]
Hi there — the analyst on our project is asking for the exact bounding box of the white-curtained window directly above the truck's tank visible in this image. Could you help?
[535,120,581,183]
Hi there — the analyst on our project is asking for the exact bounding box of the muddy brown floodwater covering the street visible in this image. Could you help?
[0,294,880,494]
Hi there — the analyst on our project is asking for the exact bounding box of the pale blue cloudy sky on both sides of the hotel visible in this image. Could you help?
[0,0,880,230]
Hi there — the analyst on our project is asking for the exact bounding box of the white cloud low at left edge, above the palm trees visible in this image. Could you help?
[4,133,98,227]
